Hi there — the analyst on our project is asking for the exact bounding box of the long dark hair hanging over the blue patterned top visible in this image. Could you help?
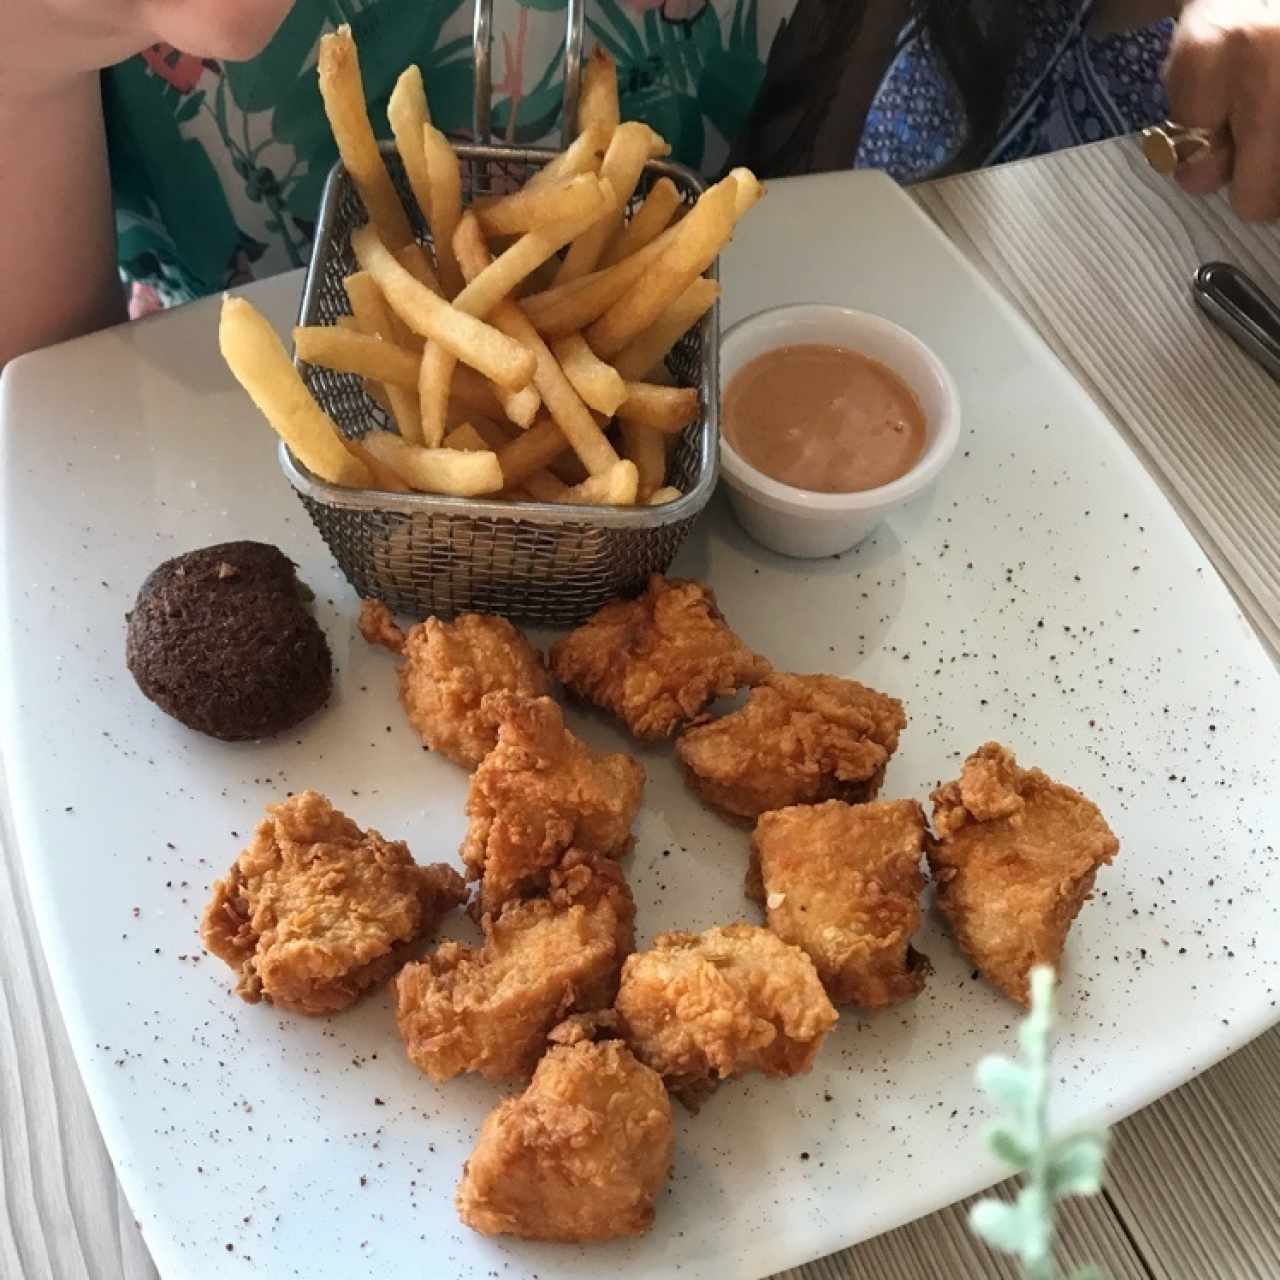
[730,0,1027,178]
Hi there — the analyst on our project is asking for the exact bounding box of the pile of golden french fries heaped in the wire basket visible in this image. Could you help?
[219,26,763,506]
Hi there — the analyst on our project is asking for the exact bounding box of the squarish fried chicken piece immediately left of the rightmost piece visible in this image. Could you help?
[748,800,929,1009]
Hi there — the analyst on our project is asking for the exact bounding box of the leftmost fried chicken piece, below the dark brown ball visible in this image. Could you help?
[200,791,466,1014]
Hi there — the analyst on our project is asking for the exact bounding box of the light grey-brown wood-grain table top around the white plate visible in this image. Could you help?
[0,141,1280,1280]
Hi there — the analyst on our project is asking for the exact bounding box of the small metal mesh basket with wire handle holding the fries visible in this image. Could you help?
[280,4,719,626]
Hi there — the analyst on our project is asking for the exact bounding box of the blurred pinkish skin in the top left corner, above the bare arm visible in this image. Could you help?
[0,0,293,99]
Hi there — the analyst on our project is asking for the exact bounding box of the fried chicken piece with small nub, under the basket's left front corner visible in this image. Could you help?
[360,600,552,769]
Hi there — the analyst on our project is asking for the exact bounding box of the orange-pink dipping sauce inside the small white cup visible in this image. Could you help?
[722,343,925,493]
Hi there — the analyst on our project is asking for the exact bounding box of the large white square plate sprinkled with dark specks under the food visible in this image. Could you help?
[0,174,1280,1280]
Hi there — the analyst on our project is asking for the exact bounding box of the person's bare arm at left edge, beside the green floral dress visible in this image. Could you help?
[0,72,125,367]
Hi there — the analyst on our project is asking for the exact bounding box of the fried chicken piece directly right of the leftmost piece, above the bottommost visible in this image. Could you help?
[396,849,635,1080]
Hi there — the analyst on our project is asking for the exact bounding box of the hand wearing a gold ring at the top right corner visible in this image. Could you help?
[1165,0,1280,221]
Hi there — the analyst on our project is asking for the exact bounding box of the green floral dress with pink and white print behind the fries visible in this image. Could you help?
[104,0,768,310]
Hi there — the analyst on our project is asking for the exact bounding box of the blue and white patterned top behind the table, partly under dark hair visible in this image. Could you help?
[854,0,1174,182]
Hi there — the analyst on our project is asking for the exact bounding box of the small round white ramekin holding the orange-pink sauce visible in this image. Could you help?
[721,305,960,557]
